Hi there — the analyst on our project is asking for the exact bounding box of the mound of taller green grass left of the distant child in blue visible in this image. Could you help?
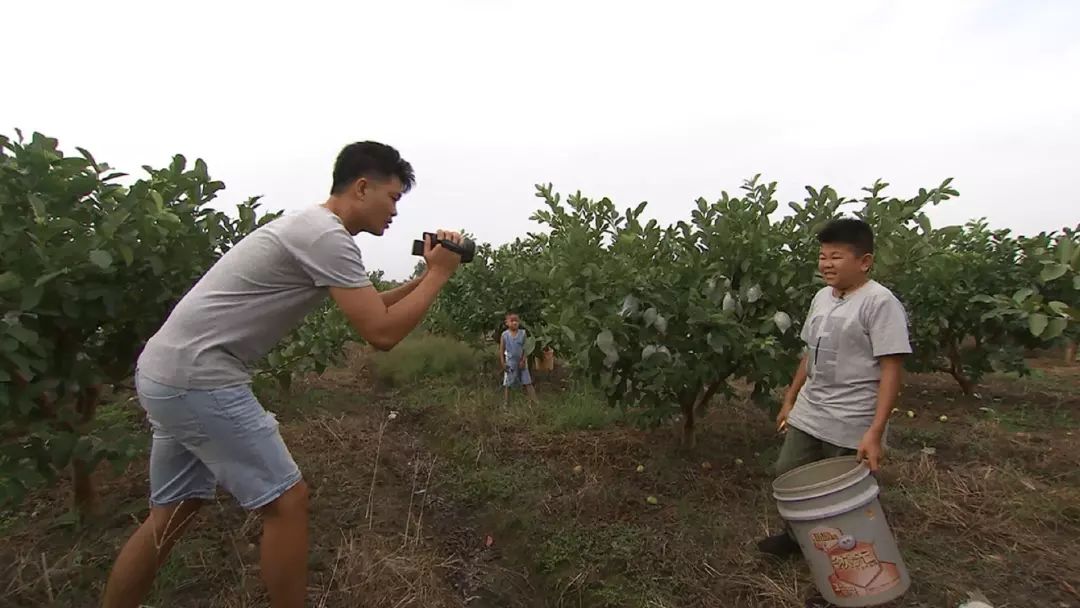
[372,335,481,387]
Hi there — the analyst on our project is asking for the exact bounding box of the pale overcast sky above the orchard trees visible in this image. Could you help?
[0,0,1080,278]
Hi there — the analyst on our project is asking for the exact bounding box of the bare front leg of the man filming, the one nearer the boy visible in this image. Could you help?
[260,481,308,608]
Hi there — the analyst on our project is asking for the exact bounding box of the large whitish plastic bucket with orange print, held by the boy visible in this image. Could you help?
[772,456,912,607]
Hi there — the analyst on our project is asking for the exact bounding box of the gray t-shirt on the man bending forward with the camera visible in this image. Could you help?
[138,205,372,389]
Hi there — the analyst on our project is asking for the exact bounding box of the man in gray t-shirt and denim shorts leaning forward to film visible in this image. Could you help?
[104,141,462,608]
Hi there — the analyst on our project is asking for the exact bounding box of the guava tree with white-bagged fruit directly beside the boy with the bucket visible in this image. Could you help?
[535,179,839,446]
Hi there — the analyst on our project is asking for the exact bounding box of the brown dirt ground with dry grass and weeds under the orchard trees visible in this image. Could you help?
[0,356,1080,608]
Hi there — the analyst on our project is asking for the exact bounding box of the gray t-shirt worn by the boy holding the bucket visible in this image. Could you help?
[787,281,912,449]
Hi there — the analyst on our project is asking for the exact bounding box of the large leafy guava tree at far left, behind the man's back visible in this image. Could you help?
[0,133,270,512]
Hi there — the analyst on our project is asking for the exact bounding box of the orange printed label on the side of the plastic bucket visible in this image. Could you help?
[810,526,900,597]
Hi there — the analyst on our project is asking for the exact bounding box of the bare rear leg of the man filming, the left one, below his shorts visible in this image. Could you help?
[102,499,203,608]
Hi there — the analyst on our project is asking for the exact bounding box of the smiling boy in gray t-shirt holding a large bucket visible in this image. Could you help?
[758,218,912,556]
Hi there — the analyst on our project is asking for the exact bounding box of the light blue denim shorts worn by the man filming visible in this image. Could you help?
[135,373,300,510]
